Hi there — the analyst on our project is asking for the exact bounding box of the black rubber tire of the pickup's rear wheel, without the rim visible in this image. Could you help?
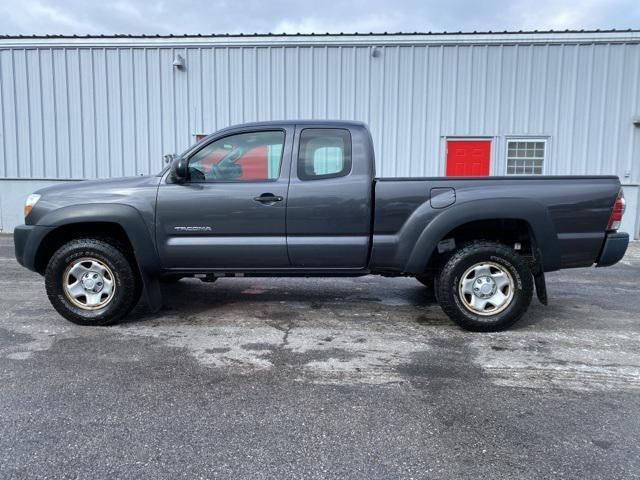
[435,241,533,332]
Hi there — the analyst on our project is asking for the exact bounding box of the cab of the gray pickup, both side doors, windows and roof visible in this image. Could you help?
[156,122,374,273]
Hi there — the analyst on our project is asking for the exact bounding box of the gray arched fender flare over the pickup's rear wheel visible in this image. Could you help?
[405,198,560,274]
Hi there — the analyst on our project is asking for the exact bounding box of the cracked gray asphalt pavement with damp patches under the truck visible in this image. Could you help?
[0,235,640,479]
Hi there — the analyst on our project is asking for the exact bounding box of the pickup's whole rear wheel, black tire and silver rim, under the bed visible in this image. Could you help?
[436,241,533,332]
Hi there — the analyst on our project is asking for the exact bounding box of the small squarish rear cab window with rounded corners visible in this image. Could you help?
[298,128,351,180]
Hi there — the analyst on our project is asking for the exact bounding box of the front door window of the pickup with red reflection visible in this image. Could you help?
[189,131,285,182]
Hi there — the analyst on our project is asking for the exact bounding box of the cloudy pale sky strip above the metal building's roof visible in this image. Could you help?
[0,0,640,35]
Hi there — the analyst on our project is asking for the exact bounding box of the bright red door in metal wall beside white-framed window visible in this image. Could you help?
[447,140,491,177]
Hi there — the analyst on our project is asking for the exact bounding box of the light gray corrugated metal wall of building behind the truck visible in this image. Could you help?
[0,40,640,183]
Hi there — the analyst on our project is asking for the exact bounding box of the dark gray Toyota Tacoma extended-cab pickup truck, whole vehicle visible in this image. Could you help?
[15,121,629,331]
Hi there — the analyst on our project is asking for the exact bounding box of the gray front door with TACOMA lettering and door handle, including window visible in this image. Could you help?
[156,127,294,270]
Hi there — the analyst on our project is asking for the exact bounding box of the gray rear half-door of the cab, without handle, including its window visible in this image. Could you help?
[287,125,373,269]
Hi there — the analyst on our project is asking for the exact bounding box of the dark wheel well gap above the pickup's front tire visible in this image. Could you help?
[35,222,133,274]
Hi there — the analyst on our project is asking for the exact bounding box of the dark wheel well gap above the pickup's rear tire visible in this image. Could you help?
[426,218,535,272]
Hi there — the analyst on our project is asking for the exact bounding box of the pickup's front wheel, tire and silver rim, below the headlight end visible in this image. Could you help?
[45,238,141,326]
